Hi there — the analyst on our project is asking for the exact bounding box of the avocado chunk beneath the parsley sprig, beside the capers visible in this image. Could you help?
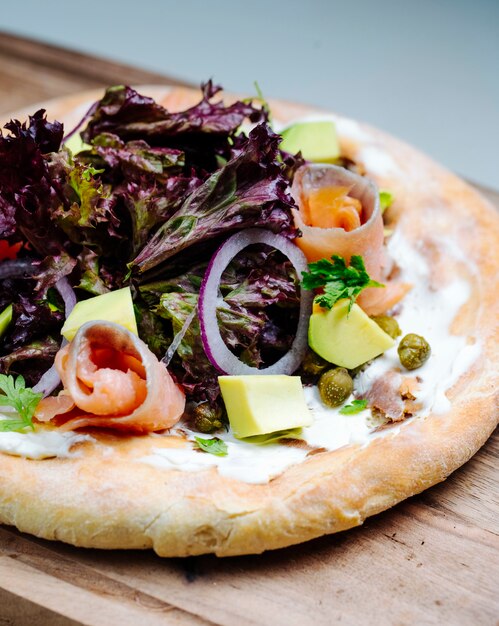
[308,300,395,369]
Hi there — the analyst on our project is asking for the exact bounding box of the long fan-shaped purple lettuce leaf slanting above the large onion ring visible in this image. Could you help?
[130,124,296,273]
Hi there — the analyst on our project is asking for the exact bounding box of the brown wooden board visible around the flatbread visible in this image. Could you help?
[0,34,499,626]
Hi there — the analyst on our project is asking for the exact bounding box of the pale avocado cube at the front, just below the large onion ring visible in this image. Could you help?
[218,374,313,438]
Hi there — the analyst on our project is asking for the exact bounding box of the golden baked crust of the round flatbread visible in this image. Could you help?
[0,88,499,556]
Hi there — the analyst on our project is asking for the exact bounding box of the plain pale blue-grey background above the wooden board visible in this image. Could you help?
[0,0,499,189]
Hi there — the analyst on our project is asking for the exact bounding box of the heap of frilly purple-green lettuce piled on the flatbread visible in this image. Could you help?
[0,81,302,402]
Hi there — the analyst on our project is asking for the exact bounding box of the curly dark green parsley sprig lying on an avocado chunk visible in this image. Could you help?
[302,254,384,311]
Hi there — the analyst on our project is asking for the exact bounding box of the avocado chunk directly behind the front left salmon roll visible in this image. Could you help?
[61,287,139,341]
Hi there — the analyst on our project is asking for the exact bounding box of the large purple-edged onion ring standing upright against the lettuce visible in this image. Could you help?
[199,228,313,376]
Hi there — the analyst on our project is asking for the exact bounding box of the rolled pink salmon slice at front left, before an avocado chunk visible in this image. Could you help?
[35,321,185,433]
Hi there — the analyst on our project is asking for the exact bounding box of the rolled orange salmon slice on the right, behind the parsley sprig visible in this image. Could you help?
[291,163,410,315]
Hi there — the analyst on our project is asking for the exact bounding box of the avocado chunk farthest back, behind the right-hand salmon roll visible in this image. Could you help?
[279,120,340,163]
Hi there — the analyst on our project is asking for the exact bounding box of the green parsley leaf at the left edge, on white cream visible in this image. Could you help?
[0,374,43,432]
